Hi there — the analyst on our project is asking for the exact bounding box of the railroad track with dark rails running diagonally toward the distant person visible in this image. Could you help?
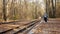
[0,20,40,34]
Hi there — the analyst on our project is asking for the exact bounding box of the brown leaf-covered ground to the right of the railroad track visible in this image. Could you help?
[29,18,60,34]
